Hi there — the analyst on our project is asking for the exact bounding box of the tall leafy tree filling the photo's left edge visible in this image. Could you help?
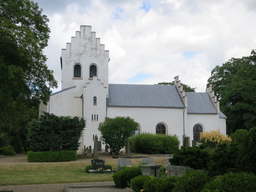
[0,0,57,146]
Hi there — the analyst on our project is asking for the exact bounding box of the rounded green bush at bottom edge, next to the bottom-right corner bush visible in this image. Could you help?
[172,171,211,192]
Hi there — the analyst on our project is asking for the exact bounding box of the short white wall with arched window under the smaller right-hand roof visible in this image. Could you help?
[186,114,226,146]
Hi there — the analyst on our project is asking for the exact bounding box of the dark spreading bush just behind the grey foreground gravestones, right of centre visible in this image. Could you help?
[170,147,210,169]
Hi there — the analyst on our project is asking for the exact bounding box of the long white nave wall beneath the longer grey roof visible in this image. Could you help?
[107,107,183,142]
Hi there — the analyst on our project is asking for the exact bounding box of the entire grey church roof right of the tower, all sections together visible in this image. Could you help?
[107,84,226,118]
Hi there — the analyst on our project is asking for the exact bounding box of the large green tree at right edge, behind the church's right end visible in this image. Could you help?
[208,50,256,133]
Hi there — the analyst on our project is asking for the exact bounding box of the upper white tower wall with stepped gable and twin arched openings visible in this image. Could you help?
[62,26,109,89]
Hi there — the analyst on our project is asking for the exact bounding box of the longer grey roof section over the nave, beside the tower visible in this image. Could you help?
[107,84,184,108]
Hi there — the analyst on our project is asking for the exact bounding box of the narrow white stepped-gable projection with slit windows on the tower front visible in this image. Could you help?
[83,77,107,147]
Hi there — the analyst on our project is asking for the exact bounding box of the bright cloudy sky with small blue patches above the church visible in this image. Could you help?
[34,0,256,92]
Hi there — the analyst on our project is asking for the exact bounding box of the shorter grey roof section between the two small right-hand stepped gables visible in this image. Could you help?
[186,92,217,114]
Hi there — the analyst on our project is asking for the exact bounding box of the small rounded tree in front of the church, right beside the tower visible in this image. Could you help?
[98,117,138,155]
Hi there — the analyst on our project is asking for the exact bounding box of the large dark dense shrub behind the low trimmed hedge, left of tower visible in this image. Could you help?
[28,113,85,152]
